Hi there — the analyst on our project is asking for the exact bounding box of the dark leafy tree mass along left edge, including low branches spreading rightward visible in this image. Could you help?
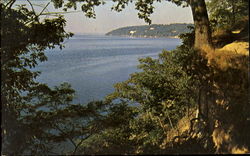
[0,0,114,155]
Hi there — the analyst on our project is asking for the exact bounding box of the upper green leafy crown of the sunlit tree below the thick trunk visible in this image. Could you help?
[105,51,193,122]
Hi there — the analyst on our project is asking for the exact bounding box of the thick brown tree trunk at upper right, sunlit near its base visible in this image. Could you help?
[189,0,212,50]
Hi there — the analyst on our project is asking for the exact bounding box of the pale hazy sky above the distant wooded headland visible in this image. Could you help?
[14,0,193,34]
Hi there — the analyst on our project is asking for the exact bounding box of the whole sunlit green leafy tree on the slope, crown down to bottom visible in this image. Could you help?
[103,51,196,153]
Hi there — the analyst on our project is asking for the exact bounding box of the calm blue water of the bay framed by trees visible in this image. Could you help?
[36,35,181,103]
